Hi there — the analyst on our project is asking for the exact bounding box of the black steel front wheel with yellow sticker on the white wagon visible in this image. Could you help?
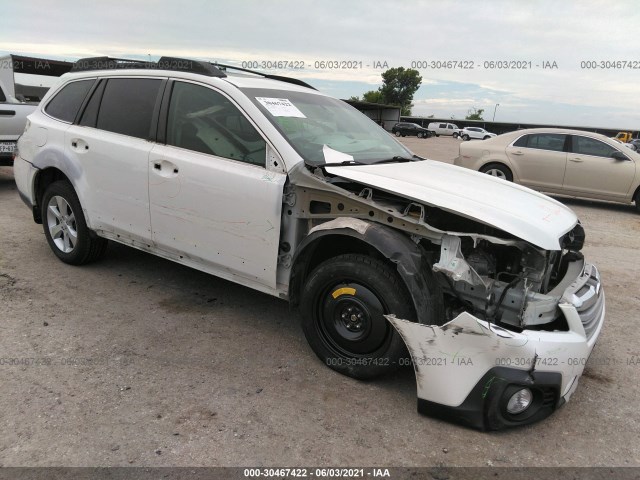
[300,254,416,379]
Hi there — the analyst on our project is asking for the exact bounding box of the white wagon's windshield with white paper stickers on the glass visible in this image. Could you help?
[242,88,413,165]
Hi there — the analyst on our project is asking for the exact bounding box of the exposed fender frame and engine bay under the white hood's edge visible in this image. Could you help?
[283,162,584,331]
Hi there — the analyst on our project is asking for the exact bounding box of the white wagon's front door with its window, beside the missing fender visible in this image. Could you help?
[148,81,286,288]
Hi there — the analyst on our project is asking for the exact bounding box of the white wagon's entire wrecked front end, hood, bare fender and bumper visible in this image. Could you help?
[283,158,605,430]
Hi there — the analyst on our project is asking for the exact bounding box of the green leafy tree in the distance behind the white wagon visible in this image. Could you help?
[356,67,422,115]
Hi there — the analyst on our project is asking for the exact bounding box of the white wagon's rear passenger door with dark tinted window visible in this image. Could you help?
[65,78,166,242]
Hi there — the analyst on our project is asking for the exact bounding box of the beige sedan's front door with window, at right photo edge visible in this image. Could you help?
[564,135,636,200]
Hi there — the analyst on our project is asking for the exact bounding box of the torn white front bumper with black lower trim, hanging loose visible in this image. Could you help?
[387,265,605,430]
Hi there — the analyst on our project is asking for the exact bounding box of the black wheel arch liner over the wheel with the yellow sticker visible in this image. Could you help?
[289,218,443,324]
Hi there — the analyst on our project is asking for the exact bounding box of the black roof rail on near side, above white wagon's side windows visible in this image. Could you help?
[71,57,227,78]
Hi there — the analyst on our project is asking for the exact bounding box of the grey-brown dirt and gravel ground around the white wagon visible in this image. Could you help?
[0,137,640,466]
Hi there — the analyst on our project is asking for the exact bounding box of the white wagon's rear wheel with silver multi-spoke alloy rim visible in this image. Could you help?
[41,181,108,265]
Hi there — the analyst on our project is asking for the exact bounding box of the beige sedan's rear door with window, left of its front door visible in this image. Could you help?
[506,133,568,192]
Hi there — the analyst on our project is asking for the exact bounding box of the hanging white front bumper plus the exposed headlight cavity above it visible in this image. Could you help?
[387,232,605,430]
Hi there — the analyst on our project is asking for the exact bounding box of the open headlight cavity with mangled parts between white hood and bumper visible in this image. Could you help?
[433,224,584,329]
